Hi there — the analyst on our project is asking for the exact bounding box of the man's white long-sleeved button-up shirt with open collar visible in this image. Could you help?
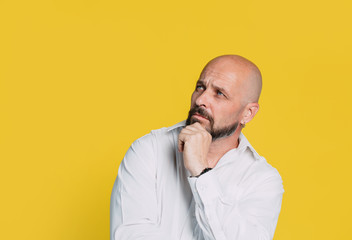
[110,121,284,240]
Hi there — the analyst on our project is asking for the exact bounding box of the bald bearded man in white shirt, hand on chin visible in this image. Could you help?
[110,55,284,240]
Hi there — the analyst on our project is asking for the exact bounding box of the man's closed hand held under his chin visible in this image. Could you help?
[178,122,211,176]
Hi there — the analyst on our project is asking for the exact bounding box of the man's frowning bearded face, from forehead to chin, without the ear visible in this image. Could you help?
[186,62,243,140]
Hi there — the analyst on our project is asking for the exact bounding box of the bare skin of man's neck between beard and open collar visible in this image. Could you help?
[207,127,242,168]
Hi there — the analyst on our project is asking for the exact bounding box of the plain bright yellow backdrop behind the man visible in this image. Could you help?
[0,0,352,240]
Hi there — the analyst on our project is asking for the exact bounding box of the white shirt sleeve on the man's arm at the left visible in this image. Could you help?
[110,134,167,240]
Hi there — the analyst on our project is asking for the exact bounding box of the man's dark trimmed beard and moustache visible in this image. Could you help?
[186,106,238,141]
